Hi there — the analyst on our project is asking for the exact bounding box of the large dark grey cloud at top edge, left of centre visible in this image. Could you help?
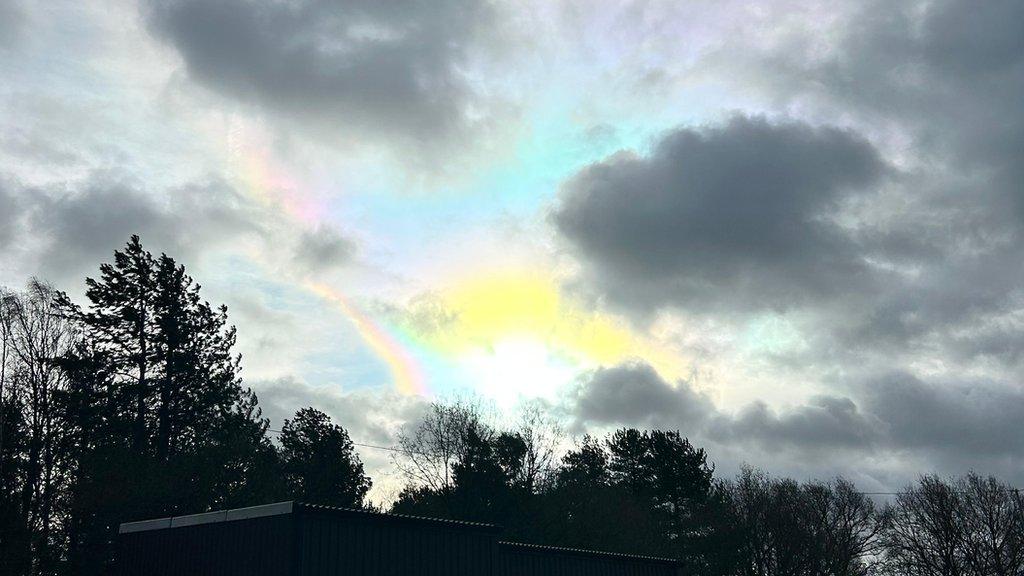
[147,0,493,142]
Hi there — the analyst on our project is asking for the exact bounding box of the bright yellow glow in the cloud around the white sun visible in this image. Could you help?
[407,272,683,399]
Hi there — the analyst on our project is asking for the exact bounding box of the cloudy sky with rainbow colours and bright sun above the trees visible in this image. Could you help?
[0,0,1024,498]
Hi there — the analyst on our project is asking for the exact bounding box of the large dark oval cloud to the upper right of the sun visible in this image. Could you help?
[553,116,887,307]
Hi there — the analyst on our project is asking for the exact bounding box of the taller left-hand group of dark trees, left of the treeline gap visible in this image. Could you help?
[0,237,370,575]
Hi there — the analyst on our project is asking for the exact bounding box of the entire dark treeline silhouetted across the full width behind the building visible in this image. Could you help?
[0,237,1024,576]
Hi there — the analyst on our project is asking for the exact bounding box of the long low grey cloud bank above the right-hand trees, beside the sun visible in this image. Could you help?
[563,364,1024,479]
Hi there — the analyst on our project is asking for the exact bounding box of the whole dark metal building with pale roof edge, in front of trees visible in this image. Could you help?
[118,502,679,576]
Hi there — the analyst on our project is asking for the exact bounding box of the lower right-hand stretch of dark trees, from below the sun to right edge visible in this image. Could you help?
[393,404,1024,576]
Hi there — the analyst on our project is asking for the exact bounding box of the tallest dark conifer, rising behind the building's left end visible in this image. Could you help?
[54,236,274,574]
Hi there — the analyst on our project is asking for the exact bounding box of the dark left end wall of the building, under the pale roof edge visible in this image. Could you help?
[118,515,294,576]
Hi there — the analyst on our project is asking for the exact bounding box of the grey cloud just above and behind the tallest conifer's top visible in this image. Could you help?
[0,173,259,281]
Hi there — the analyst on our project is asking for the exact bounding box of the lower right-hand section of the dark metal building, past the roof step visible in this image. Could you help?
[498,542,681,576]
